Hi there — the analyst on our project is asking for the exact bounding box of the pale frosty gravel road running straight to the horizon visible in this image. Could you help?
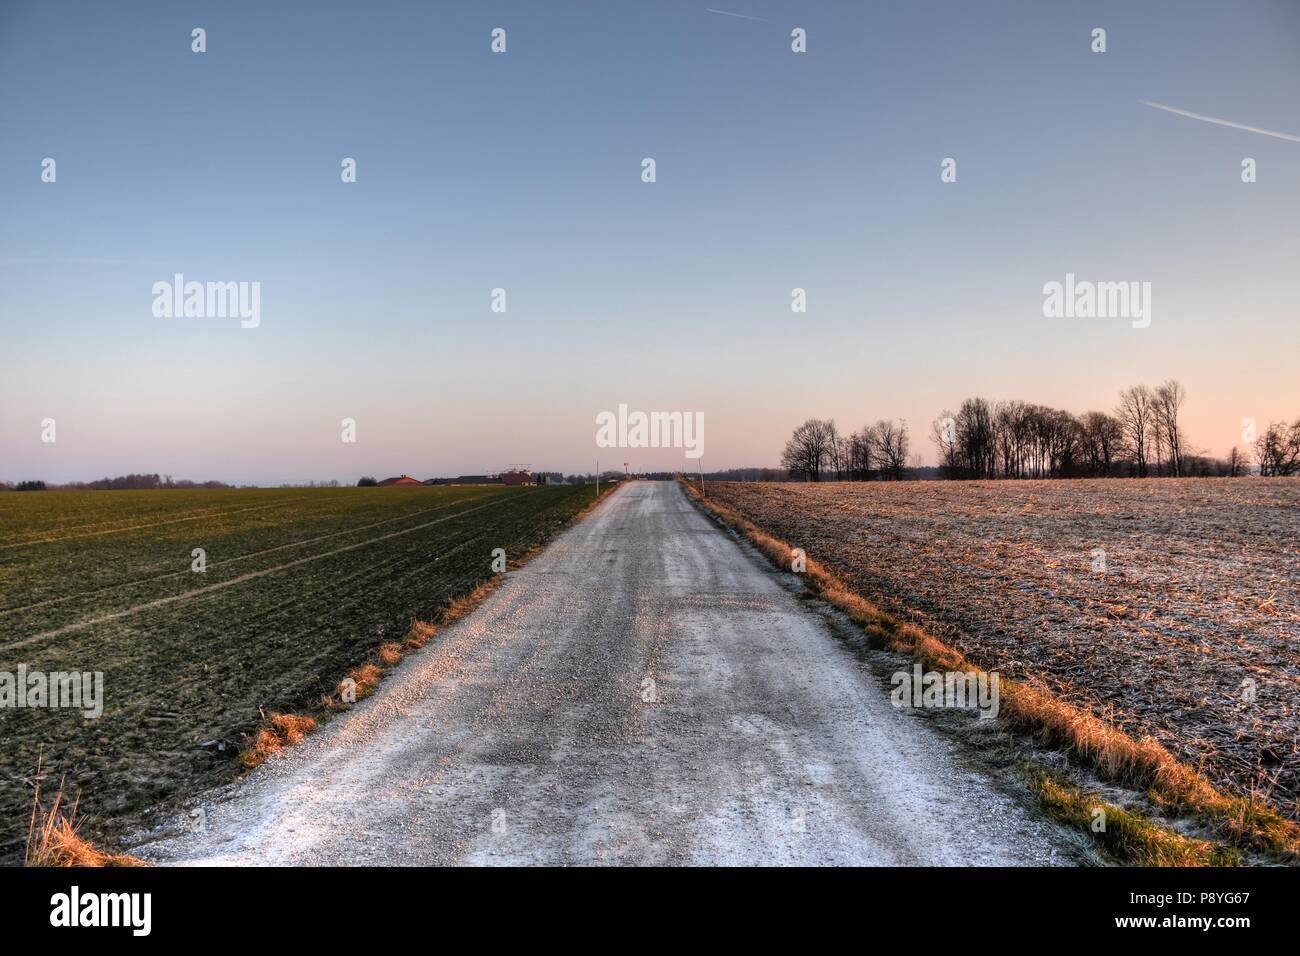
[135,481,1069,865]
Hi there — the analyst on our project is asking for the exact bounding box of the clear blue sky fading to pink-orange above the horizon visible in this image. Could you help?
[0,0,1300,483]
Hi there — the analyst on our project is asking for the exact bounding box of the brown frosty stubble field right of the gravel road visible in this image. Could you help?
[709,479,1300,817]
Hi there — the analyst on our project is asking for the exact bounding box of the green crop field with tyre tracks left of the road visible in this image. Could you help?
[0,486,594,862]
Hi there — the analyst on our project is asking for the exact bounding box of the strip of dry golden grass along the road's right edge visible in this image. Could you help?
[679,477,1300,864]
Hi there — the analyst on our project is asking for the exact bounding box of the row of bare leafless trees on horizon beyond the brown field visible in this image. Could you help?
[781,378,1300,481]
